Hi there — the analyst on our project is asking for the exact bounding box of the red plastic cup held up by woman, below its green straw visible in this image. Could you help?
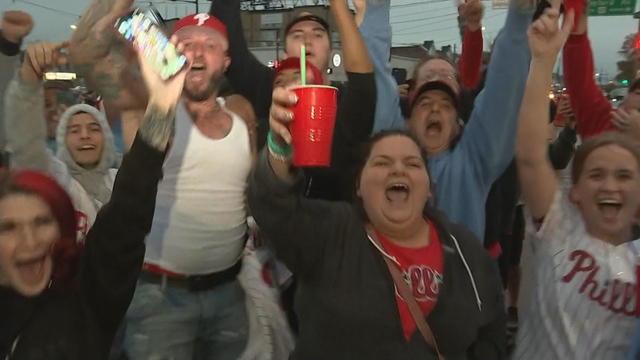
[291,85,338,167]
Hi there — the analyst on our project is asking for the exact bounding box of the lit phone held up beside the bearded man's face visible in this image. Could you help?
[115,9,187,80]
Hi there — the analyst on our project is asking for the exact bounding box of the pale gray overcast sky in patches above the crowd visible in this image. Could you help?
[0,0,638,77]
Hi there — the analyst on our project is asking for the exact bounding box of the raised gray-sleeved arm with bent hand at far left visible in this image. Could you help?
[4,41,66,175]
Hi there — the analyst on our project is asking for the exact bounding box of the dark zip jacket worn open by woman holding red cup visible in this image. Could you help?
[248,152,505,360]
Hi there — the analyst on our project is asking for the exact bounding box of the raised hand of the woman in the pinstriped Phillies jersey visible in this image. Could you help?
[527,0,574,63]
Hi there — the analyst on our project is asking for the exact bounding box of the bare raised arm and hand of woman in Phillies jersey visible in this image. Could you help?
[516,0,573,219]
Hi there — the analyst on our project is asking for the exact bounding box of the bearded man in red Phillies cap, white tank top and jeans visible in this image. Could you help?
[124,14,253,360]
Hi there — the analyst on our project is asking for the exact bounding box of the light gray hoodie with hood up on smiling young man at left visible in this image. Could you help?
[4,73,118,238]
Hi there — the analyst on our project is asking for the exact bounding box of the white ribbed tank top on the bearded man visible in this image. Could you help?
[145,98,252,275]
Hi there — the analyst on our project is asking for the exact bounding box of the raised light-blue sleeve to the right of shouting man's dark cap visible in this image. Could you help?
[454,1,533,189]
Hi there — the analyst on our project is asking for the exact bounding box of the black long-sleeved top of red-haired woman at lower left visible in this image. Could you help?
[0,138,164,360]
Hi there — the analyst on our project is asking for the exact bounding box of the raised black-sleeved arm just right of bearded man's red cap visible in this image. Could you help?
[209,0,275,123]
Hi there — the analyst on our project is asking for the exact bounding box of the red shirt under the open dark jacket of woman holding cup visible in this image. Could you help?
[377,223,444,341]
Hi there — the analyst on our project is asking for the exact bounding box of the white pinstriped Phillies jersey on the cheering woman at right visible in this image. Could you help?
[513,190,640,360]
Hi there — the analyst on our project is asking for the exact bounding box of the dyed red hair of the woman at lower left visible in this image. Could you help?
[0,169,81,288]
